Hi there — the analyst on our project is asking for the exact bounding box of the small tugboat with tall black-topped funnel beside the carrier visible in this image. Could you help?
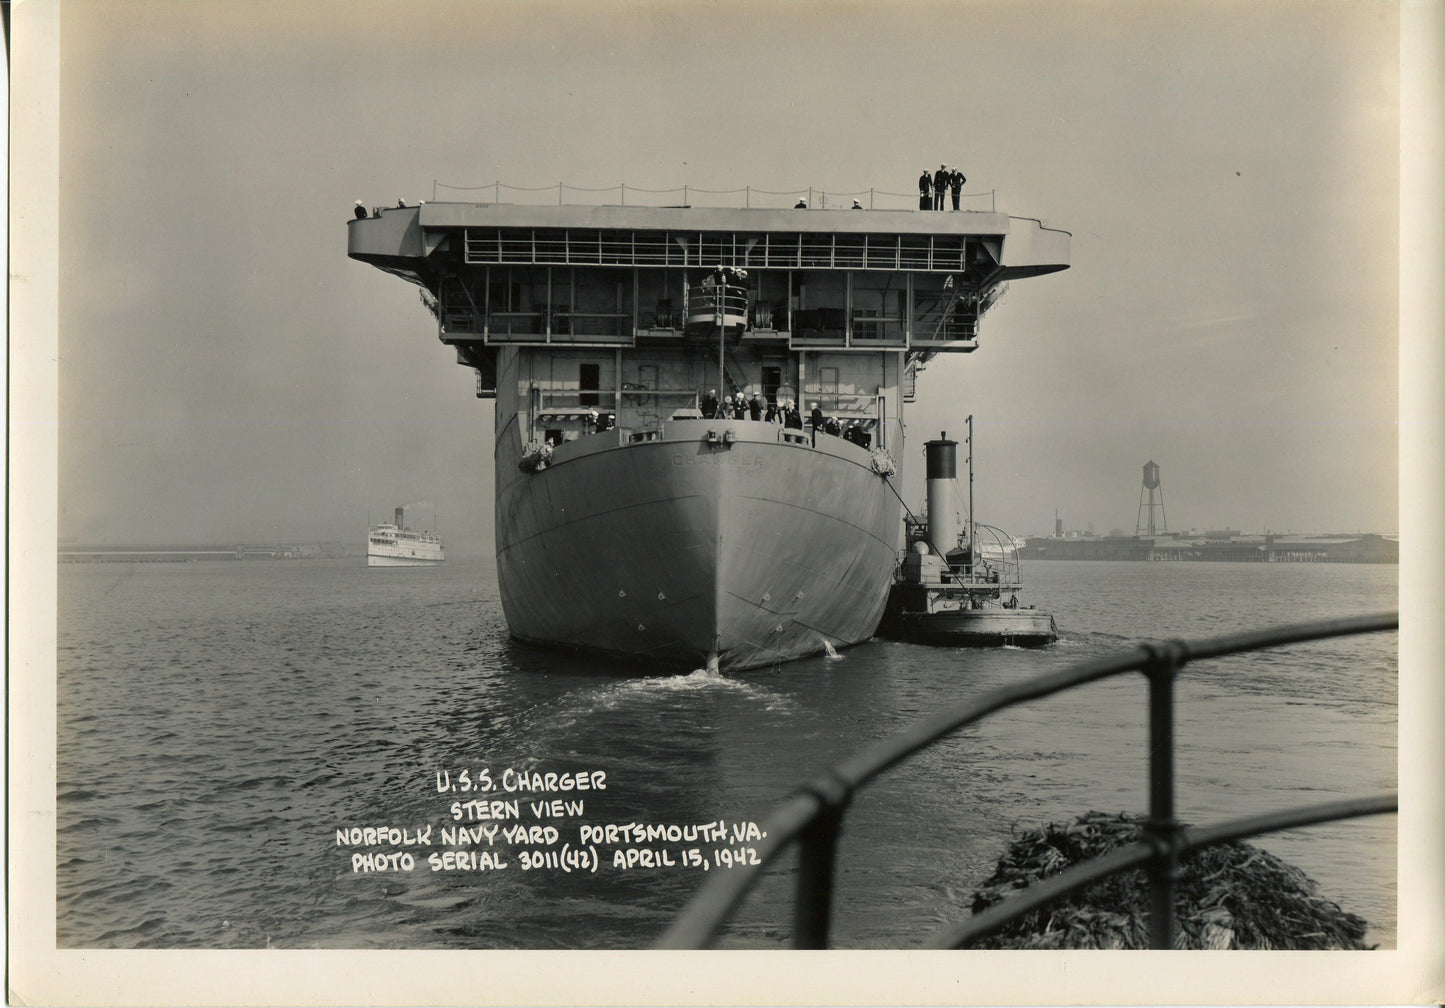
[879,416,1059,647]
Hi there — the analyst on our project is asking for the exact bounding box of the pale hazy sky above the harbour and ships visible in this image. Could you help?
[59,0,1399,555]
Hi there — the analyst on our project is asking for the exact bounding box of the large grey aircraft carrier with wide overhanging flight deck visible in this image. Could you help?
[348,194,1069,670]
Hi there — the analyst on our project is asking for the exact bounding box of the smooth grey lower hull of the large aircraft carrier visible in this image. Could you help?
[497,420,899,672]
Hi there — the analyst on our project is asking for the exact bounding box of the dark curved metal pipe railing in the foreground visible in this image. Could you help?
[657,612,1400,949]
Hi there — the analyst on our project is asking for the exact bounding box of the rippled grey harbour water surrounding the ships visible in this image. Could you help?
[56,560,1399,949]
